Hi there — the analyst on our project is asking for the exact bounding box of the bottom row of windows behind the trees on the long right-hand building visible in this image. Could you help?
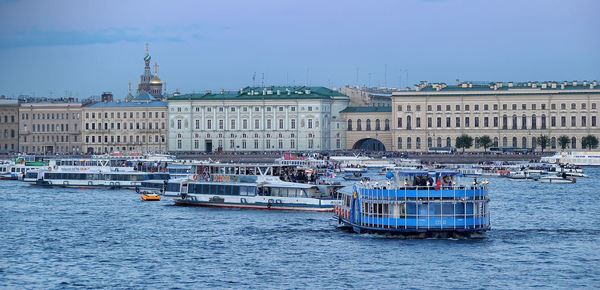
[397,137,585,150]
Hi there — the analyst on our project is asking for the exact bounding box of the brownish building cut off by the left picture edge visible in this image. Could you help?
[0,99,19,154]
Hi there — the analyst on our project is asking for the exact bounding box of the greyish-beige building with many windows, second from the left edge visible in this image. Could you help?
[19,100,82,154]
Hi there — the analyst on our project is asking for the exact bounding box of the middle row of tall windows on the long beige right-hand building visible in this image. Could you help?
[394,115,597,131]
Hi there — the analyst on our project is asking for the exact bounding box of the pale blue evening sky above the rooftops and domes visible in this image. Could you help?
[0,0,600,98]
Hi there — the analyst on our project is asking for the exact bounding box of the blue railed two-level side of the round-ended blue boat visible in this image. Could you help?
[355,185,489,230]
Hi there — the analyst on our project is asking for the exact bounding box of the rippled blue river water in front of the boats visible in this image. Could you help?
[0,168,600,288]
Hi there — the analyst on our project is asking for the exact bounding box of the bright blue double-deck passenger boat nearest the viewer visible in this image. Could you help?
[334,171,490,238]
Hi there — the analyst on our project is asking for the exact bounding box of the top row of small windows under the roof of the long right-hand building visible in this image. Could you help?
[398,103,596,112]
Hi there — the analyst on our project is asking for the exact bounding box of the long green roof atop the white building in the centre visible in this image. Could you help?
[168,86,349,101]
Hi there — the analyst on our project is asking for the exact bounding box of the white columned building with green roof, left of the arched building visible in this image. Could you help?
[168,87,349,152]
